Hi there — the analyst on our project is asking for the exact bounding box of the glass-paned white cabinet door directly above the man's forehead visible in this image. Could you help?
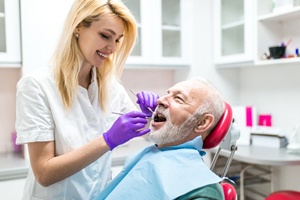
[154,0,191,65]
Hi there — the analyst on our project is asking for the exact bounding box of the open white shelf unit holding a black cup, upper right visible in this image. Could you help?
[255,0,300,65]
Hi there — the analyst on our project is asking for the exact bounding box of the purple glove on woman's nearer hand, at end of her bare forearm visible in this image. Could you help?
[103,111,150,150]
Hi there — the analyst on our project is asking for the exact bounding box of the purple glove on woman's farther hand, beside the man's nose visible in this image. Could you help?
[136,91,159,117]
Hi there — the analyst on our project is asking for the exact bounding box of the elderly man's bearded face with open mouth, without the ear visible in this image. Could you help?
[150,81,206,145]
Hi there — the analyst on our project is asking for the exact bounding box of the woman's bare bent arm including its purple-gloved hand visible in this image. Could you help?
[28,111,150,186]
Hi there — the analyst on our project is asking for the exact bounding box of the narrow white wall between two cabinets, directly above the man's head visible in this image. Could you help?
[174,0,239,104]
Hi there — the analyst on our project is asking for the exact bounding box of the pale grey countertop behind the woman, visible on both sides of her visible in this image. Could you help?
[0,137,152,181]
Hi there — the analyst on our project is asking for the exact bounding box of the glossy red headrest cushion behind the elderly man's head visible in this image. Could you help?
[203,102,232,149]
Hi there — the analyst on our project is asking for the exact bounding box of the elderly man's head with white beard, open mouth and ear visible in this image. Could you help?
[149,80,221,148]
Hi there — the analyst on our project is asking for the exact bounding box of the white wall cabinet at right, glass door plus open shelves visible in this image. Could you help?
[214,0,300,67]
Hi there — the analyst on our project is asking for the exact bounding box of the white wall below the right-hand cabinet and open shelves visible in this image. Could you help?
[239,64,300,136]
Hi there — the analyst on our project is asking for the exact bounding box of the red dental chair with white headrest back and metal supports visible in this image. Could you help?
[203,103,240,200]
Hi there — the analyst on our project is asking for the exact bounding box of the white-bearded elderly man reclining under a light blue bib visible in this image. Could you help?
[98,78,224,200]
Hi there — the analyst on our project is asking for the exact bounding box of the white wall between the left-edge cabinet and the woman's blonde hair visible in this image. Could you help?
[20,0,74,74]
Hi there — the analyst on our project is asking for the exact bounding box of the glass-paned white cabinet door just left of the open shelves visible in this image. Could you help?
[214,0,254,65]
